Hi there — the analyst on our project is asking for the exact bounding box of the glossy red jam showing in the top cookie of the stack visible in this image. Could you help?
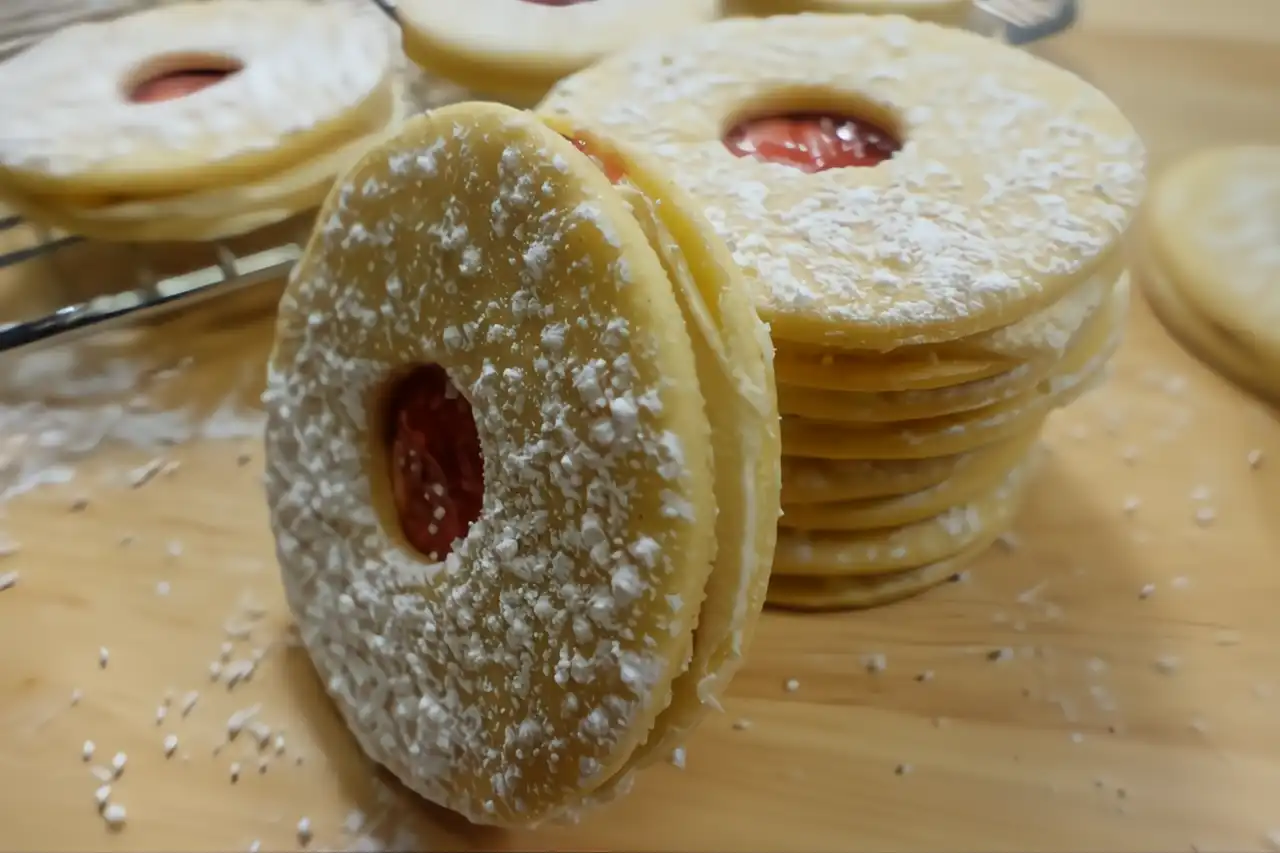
[724,113,902,174]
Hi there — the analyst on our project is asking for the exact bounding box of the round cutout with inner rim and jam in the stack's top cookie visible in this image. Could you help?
[722,92,902,174]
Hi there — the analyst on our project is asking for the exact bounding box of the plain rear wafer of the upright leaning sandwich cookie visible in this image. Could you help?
[537,119,781,804]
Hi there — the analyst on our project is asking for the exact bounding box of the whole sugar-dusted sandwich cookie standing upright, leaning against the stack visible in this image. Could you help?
[264,104,780,826]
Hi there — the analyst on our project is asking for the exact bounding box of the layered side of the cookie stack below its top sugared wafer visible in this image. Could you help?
[769,266,1129,610]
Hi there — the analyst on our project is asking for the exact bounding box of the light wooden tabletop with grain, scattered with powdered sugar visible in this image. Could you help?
[0,0,1280,852]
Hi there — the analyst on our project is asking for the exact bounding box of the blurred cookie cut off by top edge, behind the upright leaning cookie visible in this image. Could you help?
[397,0,717,108]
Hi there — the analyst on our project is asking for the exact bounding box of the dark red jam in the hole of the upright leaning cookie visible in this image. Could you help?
[387,365,484,562]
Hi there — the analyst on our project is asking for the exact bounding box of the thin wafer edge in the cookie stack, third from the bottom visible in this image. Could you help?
[780,427,1039,530]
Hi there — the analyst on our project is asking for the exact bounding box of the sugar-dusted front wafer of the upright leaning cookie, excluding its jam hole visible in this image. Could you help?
[264,105,710,822]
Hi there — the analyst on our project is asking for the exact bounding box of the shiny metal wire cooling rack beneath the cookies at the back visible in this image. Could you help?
[0,0,1078,353]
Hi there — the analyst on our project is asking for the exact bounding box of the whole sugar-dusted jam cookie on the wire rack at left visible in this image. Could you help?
[0,0,394,197]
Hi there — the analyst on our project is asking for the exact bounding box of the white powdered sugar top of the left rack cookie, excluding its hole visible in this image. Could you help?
[0,0,390,175]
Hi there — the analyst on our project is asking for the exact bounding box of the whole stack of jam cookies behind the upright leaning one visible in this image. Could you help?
[540,15,1144,607]
